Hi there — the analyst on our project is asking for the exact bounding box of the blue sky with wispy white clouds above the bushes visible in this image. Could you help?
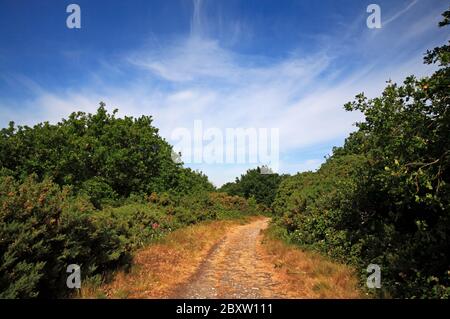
[0,0,449,186]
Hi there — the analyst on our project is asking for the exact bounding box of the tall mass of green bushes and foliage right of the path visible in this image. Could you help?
[273,11,450,298]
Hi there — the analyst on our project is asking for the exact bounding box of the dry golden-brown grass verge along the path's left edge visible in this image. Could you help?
[81,220,250,298]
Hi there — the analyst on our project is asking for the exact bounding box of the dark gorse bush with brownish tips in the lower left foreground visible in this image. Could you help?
[0,176,125,298]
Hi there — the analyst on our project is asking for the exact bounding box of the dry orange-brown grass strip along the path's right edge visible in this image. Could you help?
[261,232,363,299]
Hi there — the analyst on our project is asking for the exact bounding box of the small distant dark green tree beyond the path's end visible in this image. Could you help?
[220,166,283,207]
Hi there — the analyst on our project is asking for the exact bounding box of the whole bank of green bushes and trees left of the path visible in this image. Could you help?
[0,104,259,298]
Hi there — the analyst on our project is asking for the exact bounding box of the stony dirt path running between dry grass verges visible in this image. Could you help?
[174,218,285,298]
